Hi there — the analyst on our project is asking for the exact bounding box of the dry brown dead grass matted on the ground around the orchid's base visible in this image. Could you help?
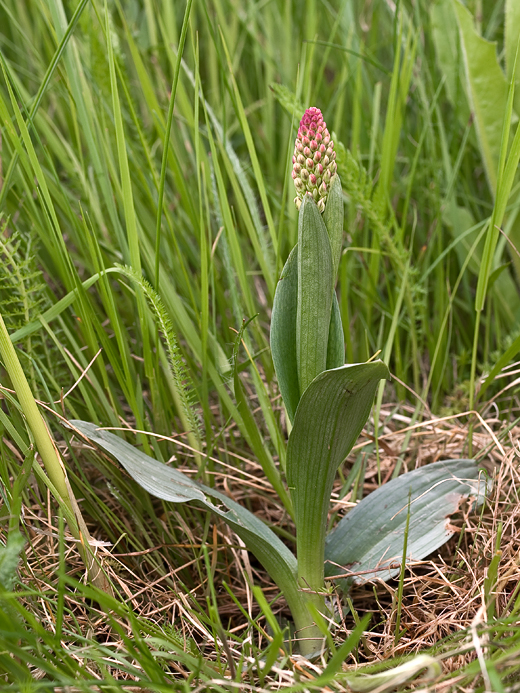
[4,405,520,692]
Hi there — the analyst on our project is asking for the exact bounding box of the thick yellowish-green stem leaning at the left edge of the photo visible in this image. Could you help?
[0,314,109,592]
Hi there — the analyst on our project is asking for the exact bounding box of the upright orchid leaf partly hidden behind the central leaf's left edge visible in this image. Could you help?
[271,246,300,423]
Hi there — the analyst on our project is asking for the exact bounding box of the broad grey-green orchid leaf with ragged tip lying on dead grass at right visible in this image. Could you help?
[325,460,486,585]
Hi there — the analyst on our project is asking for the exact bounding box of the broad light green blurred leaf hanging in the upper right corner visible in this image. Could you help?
[453,0,509,194]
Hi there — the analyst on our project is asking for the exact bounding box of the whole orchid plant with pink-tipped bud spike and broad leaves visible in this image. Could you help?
[71,108,484,656]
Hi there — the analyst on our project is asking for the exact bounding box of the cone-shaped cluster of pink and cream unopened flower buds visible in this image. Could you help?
[291,107,337,212]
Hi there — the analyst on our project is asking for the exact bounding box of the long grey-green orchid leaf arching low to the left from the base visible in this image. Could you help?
[70,420,304,628]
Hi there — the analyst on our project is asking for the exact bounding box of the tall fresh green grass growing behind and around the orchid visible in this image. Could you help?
[0,0,520,691]
